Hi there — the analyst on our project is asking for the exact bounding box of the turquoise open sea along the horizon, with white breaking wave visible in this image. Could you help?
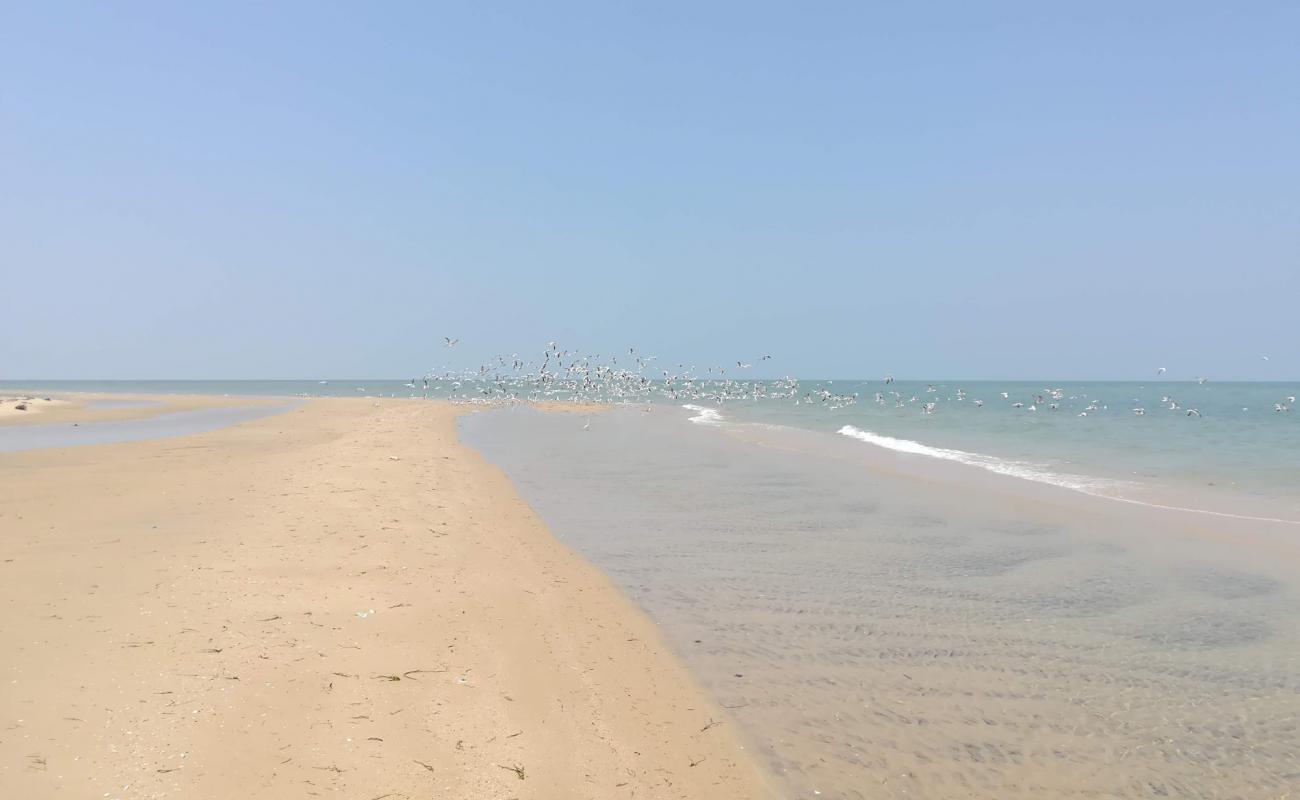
[0,379,1300,517]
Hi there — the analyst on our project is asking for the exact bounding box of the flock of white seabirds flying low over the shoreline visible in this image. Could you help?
[358,337,1296,418]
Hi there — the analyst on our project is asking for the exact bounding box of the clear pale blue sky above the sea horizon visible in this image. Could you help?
[0,1,1300,380]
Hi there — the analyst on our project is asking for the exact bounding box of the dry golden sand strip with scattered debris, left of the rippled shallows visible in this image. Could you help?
[0,399,771,800]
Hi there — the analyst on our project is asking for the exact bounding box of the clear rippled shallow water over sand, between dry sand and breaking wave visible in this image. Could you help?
[462,408,1300,799]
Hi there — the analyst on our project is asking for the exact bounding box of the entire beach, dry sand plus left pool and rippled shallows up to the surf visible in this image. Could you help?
[0,381,1300,800]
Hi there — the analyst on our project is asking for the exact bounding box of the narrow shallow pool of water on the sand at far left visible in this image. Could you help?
[0,403,296,453]
